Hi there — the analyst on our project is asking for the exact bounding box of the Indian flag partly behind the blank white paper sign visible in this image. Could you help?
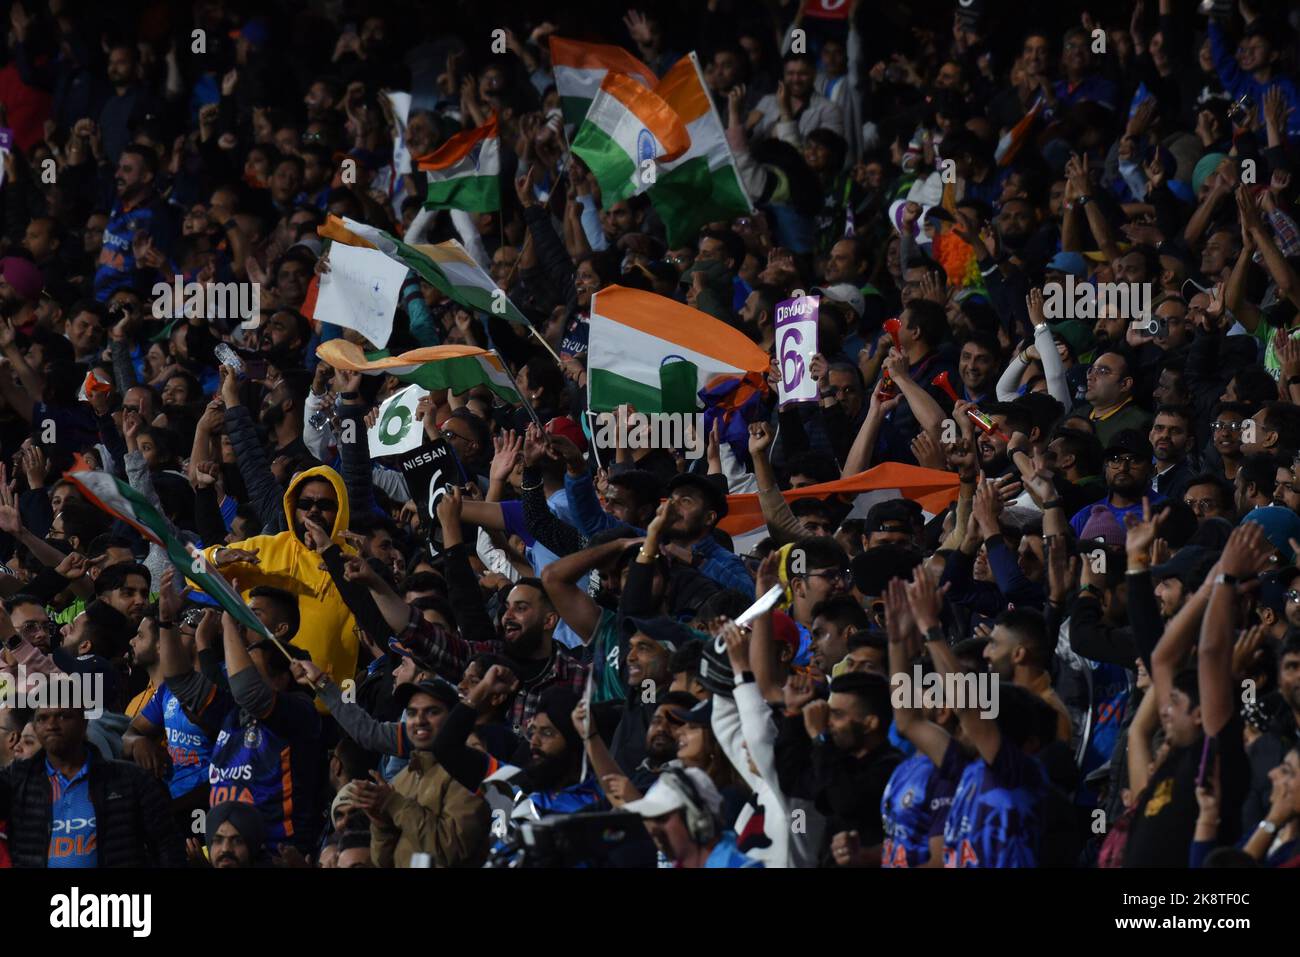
[316,216,529,325]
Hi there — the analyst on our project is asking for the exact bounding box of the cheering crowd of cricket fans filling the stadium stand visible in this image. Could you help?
[0,0,1300,867]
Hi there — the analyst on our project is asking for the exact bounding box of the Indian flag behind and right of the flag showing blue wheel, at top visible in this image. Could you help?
[646,53,754,247]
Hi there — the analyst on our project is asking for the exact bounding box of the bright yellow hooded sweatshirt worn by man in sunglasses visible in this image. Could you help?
[204,465,359,696]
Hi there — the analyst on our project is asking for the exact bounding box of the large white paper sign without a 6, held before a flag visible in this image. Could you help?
[315,243,407,348]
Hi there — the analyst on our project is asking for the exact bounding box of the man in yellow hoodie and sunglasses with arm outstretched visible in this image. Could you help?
[204,465,358,683]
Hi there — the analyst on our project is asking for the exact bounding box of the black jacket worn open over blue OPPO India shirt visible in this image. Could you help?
[0,745,186,867]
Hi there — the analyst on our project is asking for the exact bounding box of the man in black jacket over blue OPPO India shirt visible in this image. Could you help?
[0,707,185,867]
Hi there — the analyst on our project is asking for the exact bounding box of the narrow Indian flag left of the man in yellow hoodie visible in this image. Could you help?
[64,468,270,638]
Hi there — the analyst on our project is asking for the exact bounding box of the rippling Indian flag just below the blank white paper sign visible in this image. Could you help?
[316,339,521,403]
